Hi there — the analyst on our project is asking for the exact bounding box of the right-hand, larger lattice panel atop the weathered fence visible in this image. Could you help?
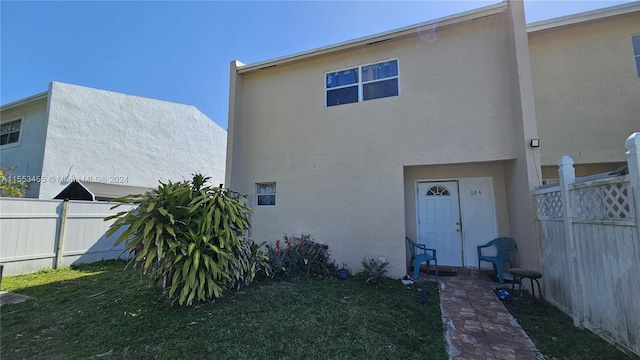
[573,182,635,221]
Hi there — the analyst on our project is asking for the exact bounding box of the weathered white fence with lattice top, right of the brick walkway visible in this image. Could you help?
[534,133,640,356]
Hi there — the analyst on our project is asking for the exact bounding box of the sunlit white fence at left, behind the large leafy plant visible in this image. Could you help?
[0,198,131,276]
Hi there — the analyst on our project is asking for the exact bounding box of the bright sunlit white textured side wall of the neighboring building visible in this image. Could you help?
[40,82,226,199]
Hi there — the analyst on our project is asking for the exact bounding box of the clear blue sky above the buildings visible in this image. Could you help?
[0,0,629,129]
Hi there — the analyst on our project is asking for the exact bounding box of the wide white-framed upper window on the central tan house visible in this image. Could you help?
[325,59,399,106]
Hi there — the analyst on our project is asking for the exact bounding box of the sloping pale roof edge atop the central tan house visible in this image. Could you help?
[237,1,509,74]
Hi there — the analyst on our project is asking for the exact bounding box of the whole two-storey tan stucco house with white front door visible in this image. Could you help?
[226,1,541,276]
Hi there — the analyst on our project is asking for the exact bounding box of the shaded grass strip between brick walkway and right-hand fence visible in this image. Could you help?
[503,294,630,360]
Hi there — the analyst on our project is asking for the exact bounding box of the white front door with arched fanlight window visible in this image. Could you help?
[418,181,462,266]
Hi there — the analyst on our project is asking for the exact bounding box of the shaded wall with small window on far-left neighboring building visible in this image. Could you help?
[0,98,47,197]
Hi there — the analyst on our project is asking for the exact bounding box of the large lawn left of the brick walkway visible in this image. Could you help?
[0,261,447,359]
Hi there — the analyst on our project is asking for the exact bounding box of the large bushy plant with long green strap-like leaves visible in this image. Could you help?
[105,174,269,305]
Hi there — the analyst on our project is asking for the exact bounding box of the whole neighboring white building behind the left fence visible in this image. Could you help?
[0,82,227,199]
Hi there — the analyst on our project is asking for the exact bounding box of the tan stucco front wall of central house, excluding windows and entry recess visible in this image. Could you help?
[228,9,535,275]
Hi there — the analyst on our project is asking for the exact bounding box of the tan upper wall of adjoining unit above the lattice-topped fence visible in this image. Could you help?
[529,12,640,166]
